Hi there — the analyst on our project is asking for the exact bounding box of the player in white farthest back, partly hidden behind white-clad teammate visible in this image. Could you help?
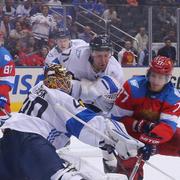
[45,29,88,64]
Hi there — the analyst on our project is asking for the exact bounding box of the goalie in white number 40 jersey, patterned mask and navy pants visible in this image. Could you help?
[0,65,144,180]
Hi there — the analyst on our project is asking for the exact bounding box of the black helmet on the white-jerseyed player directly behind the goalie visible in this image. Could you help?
[89,35,112,51]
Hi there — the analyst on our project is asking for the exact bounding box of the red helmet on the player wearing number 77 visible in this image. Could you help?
[149,56,173,75]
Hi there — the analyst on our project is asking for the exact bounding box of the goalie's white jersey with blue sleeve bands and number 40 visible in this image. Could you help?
[2,82,106,149]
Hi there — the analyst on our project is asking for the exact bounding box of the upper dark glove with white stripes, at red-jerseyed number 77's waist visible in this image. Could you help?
[133,119,155,133]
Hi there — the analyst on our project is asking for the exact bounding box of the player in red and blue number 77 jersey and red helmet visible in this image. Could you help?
[111,56,180,180]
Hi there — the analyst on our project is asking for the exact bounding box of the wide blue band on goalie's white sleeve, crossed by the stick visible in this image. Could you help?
[66,109,96,138]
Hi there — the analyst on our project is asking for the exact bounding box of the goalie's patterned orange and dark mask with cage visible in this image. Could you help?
[44,64,72,94]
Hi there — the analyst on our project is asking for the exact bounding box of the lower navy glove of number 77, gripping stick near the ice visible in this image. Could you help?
[138,144,156,161]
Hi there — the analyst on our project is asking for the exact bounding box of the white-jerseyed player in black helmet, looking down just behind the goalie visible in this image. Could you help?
[44,35,124,112]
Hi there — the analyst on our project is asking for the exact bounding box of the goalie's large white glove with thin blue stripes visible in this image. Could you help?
[100,119,144,159]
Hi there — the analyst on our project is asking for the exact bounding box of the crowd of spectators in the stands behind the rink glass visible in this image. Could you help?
[0,0,178,66]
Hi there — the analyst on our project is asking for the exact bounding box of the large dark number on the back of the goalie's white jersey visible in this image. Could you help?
[19,97,48,118]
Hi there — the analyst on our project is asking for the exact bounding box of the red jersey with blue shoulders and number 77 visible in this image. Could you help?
[110,76,180,142]
